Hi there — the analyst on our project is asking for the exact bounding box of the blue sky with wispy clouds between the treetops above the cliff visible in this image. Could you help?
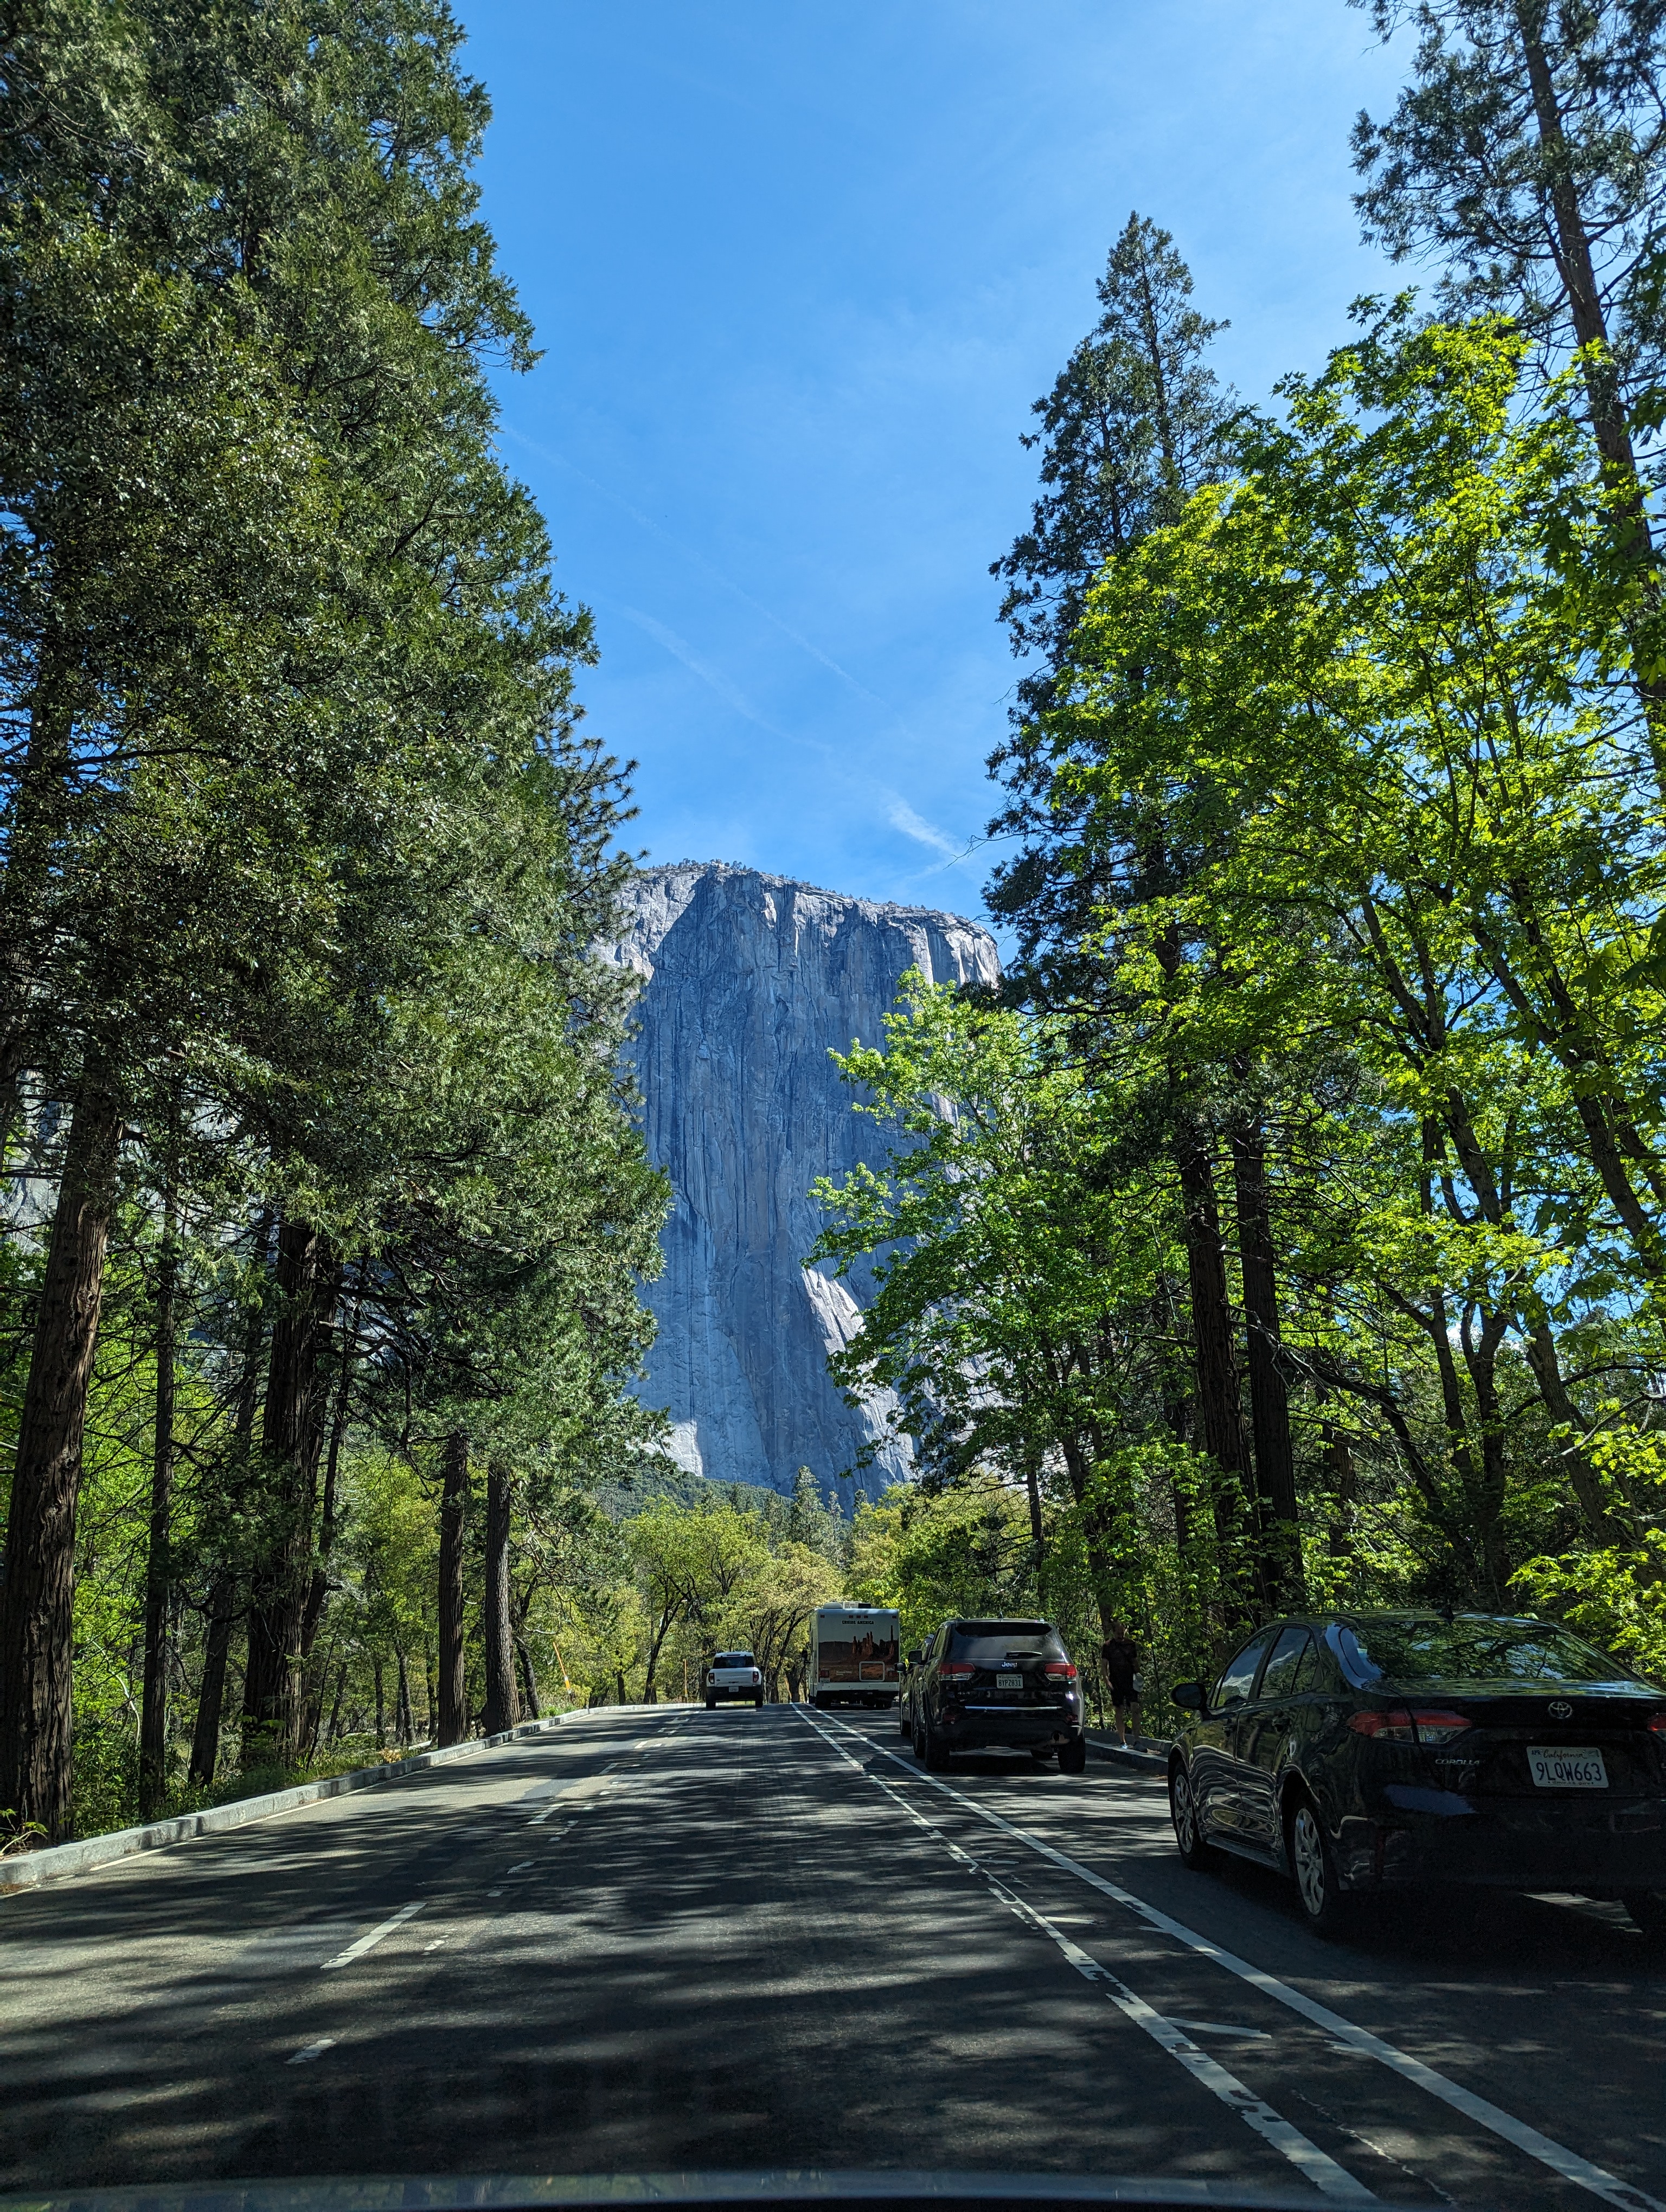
[460,0,1403,933]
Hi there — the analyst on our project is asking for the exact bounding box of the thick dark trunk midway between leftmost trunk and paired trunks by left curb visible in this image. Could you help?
[244,1221,334,1767]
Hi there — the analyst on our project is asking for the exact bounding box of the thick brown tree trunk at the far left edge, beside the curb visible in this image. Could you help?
[0,1071,121,1843]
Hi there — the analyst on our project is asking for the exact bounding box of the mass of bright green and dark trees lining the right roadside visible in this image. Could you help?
[821,0,1666,1707]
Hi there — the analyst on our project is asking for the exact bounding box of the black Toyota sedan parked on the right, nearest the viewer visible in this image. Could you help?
[1168,1612,1666,1935]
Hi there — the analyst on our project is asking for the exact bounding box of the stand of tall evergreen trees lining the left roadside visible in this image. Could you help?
[0,0,666,1841]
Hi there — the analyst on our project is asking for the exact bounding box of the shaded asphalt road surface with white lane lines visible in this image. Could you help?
[0,1706,1666,2212]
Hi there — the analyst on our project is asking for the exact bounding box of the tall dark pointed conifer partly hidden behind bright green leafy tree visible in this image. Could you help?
[989,215,1297,1597]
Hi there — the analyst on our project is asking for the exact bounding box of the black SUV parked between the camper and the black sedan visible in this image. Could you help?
[907,1619,1088,1774]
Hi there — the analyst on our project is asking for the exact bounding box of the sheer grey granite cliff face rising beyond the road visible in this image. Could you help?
[613,860,998,1495]
